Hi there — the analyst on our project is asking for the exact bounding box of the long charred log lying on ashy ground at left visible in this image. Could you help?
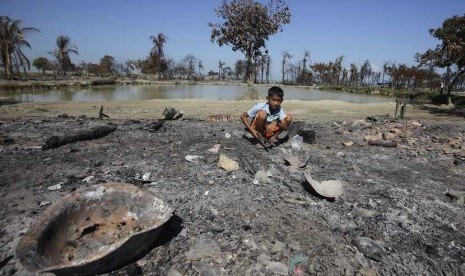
[42,126,117,150]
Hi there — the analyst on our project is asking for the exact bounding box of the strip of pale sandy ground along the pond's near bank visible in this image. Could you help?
[0,100,464,122]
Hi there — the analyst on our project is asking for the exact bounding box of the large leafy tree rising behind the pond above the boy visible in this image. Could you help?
[209,0,291,80]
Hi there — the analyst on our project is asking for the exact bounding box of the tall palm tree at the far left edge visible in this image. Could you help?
[0,16,39,79]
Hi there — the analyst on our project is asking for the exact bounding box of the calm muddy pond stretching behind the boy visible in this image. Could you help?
[0,84,393,103]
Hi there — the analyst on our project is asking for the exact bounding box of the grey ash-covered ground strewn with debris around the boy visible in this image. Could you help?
[0,116,465,275]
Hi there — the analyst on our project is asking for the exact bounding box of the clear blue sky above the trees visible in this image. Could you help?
[0,0,465,79]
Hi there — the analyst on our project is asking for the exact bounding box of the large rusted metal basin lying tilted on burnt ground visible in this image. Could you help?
[16,183,173,275]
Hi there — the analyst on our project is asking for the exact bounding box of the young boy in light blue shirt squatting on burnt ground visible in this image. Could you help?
[241,86,292,144]
